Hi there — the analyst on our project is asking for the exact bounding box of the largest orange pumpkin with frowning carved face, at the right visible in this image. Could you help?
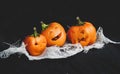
[67,17,97,46]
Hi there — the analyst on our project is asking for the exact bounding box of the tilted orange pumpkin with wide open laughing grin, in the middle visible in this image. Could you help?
[41,22,66,46]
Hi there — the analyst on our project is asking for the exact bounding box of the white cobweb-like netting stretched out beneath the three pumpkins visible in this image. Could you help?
[0,27,120,60]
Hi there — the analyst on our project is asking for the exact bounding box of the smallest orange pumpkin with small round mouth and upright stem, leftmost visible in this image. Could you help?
[24,28,47,56]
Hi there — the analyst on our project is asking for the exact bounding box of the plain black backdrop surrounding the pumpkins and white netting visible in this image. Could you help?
[0,0,120,74]
